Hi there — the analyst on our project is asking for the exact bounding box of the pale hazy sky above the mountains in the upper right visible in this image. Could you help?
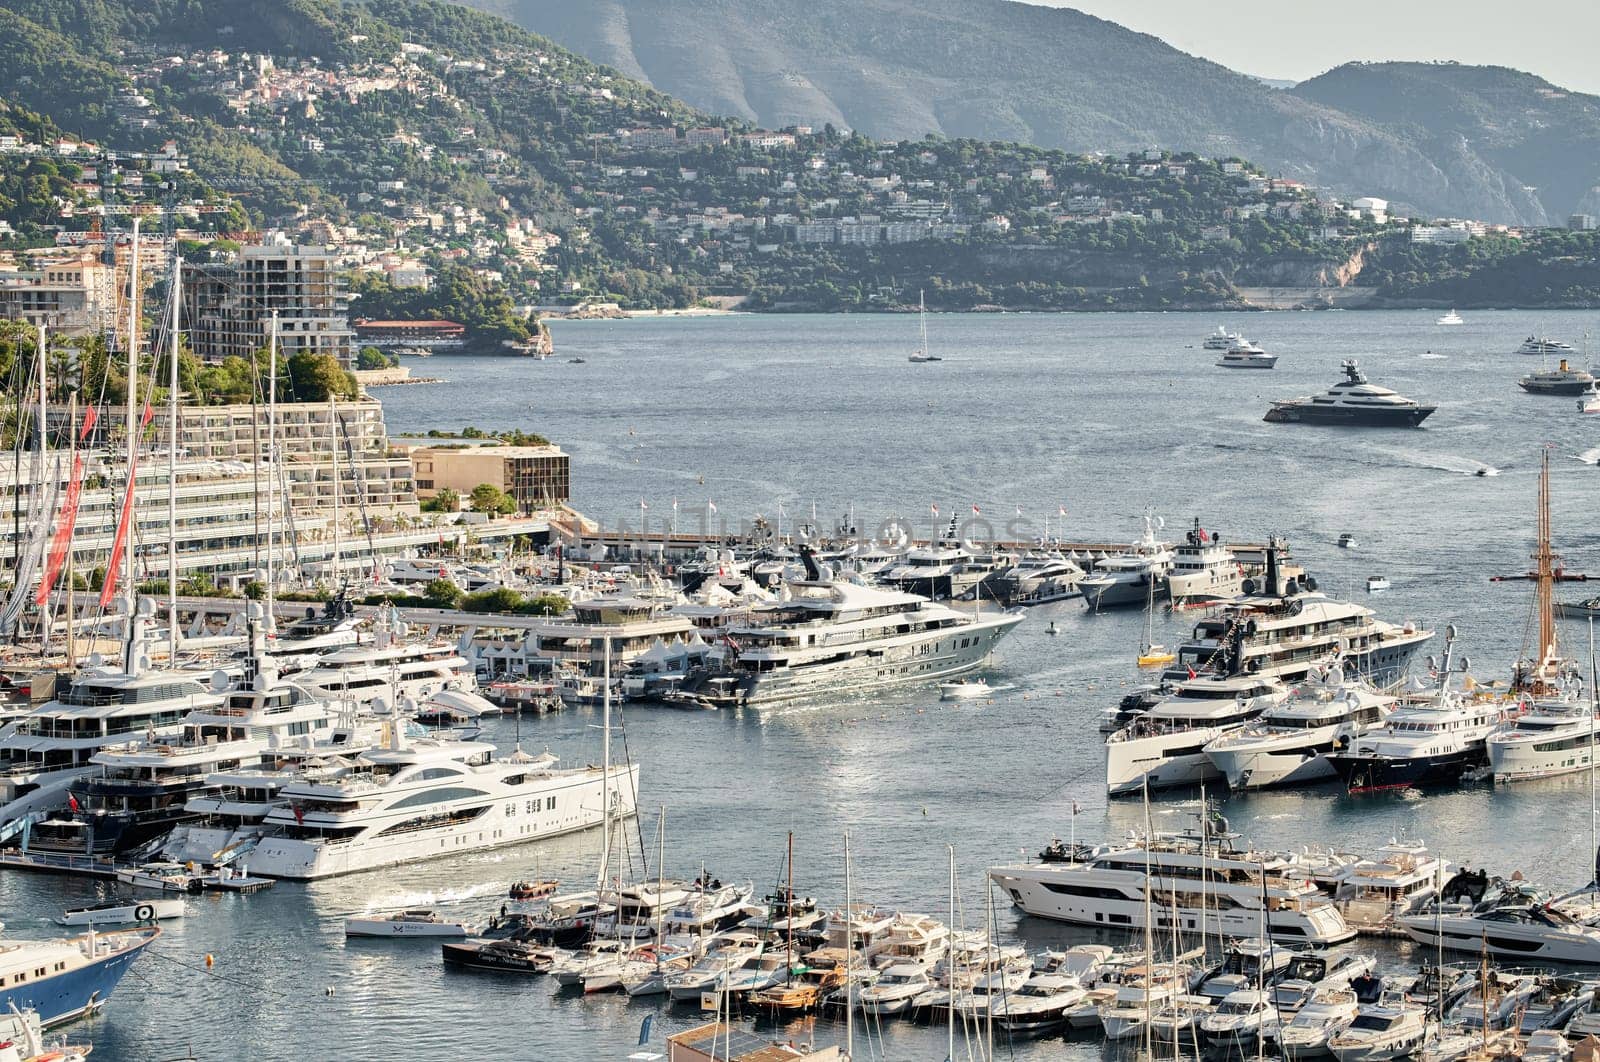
[1032,0,1600,94]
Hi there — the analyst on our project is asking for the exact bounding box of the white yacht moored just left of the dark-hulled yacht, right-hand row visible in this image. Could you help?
[1205,667,1395,790]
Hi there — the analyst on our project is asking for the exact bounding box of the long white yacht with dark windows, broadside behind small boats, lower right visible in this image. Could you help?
[989,820,1355,945]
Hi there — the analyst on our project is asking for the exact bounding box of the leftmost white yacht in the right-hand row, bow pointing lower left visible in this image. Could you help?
[1106,675,1290,797]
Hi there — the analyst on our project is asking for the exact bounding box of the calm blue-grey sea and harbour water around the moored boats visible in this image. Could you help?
[15,312,1600,1060]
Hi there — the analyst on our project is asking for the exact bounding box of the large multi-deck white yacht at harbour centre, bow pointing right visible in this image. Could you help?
[670,553,1022,707]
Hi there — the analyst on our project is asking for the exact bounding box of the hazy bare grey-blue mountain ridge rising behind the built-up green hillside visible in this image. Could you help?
[466,0,1600,224]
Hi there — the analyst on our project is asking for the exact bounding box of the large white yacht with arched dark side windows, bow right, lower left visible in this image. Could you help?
[250,720,638,880]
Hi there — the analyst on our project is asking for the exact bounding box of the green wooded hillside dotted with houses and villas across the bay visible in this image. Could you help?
[0,0,1600,315]
